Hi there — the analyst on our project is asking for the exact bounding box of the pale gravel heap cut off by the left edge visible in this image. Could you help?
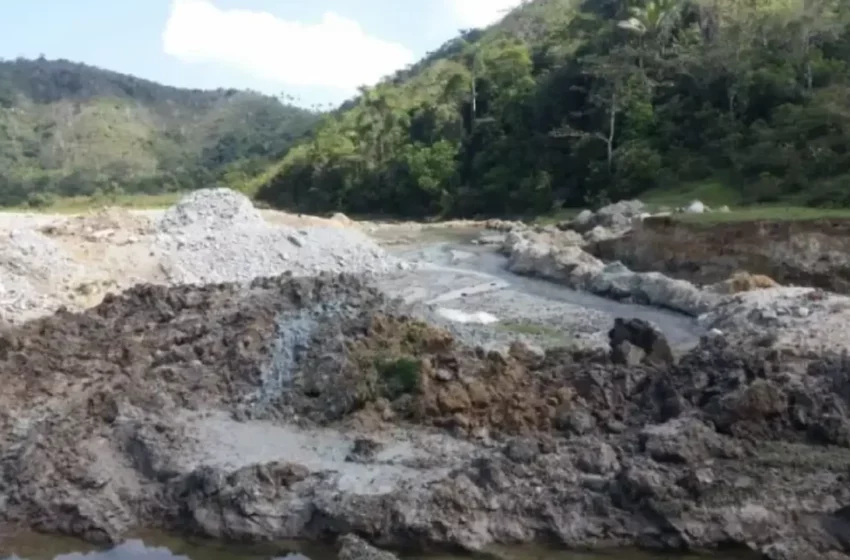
[0,229,78,322]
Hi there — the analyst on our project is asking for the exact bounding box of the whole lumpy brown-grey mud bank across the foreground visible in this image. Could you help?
[0,274,850,559]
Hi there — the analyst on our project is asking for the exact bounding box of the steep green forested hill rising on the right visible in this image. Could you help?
[259,0,850,216]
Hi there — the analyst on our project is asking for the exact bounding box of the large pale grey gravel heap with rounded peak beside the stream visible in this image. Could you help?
[155,188,408,284]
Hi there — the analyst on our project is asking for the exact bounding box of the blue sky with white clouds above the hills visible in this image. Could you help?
[0,0,520,106]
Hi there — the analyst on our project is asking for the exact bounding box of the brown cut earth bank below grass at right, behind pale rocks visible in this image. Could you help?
[585,217,850,294]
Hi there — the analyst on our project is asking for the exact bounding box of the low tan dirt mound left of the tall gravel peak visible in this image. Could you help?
[41,207,153,241]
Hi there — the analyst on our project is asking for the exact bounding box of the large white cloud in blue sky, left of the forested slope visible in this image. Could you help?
[162,0,414,92]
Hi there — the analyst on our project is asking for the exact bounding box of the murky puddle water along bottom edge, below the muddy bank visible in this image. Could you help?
[0,534,756,560]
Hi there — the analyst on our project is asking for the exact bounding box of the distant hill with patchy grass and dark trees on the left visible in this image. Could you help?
[0,59,318,205]
